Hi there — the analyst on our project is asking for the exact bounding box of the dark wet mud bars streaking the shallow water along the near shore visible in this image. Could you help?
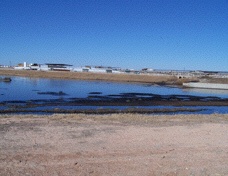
[0,91,228,114]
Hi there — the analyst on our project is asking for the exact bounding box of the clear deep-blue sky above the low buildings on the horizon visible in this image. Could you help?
[0,0,228,71]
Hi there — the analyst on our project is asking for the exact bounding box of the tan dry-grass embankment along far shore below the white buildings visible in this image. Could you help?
[0,69,196,85]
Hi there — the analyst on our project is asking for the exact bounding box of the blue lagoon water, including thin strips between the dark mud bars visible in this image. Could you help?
[0,77,228,114]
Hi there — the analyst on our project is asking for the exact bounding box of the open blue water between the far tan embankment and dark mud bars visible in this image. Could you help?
[0,77,228,101]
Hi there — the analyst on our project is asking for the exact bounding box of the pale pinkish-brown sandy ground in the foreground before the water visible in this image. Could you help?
[0,114,228,176]
